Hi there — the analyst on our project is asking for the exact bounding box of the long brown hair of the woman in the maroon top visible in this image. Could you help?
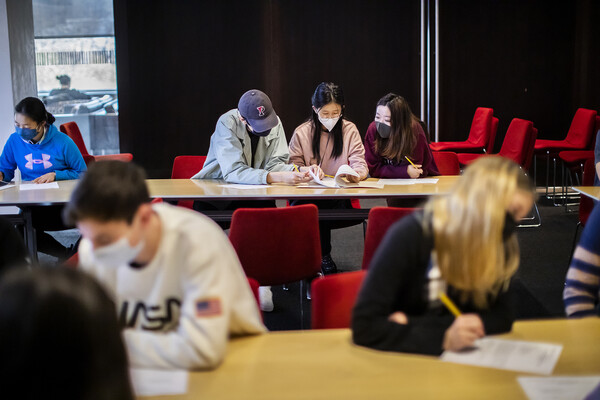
[375,93,419,163]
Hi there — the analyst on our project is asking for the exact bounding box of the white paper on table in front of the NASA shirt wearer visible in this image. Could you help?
[129,368,188,396]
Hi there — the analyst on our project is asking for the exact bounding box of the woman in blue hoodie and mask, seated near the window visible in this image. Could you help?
[0,97,86,258]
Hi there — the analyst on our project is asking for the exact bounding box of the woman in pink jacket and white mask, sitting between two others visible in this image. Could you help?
[289,82,368,274]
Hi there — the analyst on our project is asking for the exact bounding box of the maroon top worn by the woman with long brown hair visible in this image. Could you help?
[365,122,440,178]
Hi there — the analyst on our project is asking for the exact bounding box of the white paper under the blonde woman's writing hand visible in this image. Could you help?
[441,338,562,375]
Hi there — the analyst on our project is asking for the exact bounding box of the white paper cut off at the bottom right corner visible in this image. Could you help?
[517,376,600,400]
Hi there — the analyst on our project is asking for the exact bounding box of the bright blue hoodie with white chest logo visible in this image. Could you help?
[0,125,87,182]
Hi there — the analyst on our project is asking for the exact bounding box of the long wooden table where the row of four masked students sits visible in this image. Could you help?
[0,176,458,257]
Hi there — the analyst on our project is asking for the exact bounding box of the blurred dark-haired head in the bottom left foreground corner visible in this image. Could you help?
[0,267,133,400]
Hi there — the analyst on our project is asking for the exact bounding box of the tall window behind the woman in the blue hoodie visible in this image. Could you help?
[33,0,119,154]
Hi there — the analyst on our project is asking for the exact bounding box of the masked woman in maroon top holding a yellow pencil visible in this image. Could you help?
[365,93,440,179]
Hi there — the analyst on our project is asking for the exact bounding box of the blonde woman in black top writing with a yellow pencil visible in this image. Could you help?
[352,156,535,354]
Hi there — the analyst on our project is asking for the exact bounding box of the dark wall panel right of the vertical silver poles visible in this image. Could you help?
[439,0,600,150]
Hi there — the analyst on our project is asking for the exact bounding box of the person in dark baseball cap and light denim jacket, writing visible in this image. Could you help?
[192,89,311,185]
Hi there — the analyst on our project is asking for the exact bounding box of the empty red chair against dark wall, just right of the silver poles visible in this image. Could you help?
[430,107,494,153]
